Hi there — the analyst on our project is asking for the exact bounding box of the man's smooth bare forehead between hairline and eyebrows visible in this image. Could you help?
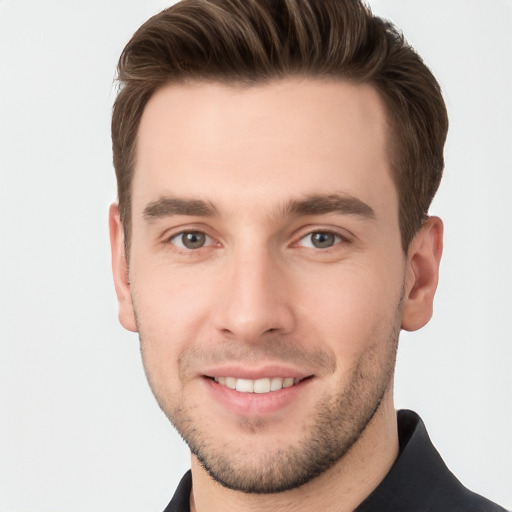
[133,78,397,219]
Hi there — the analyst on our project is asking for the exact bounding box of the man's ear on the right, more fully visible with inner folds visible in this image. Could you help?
[402,217,443,331]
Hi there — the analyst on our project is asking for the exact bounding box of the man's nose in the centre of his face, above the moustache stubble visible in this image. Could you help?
[213,247,295,343]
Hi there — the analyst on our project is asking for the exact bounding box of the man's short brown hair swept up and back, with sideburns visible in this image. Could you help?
[112,0,448,251]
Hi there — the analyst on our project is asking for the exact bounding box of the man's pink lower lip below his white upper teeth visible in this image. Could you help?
[203,377,312,417]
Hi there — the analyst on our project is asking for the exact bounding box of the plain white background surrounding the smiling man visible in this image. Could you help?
[0,0,512,512]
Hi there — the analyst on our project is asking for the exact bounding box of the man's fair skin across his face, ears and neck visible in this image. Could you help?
[110,78,442,512]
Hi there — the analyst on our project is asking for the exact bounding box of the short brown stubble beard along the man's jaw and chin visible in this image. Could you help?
[139,322,400,494]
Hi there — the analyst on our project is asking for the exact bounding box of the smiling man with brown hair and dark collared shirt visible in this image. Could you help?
[110,0,503,512]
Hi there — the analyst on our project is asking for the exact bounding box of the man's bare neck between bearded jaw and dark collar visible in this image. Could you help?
[190,393,398,512]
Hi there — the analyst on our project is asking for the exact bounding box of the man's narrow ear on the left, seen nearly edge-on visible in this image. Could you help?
[108,203,137,332]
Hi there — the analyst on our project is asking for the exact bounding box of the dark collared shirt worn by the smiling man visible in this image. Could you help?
[164,411,506,512]
